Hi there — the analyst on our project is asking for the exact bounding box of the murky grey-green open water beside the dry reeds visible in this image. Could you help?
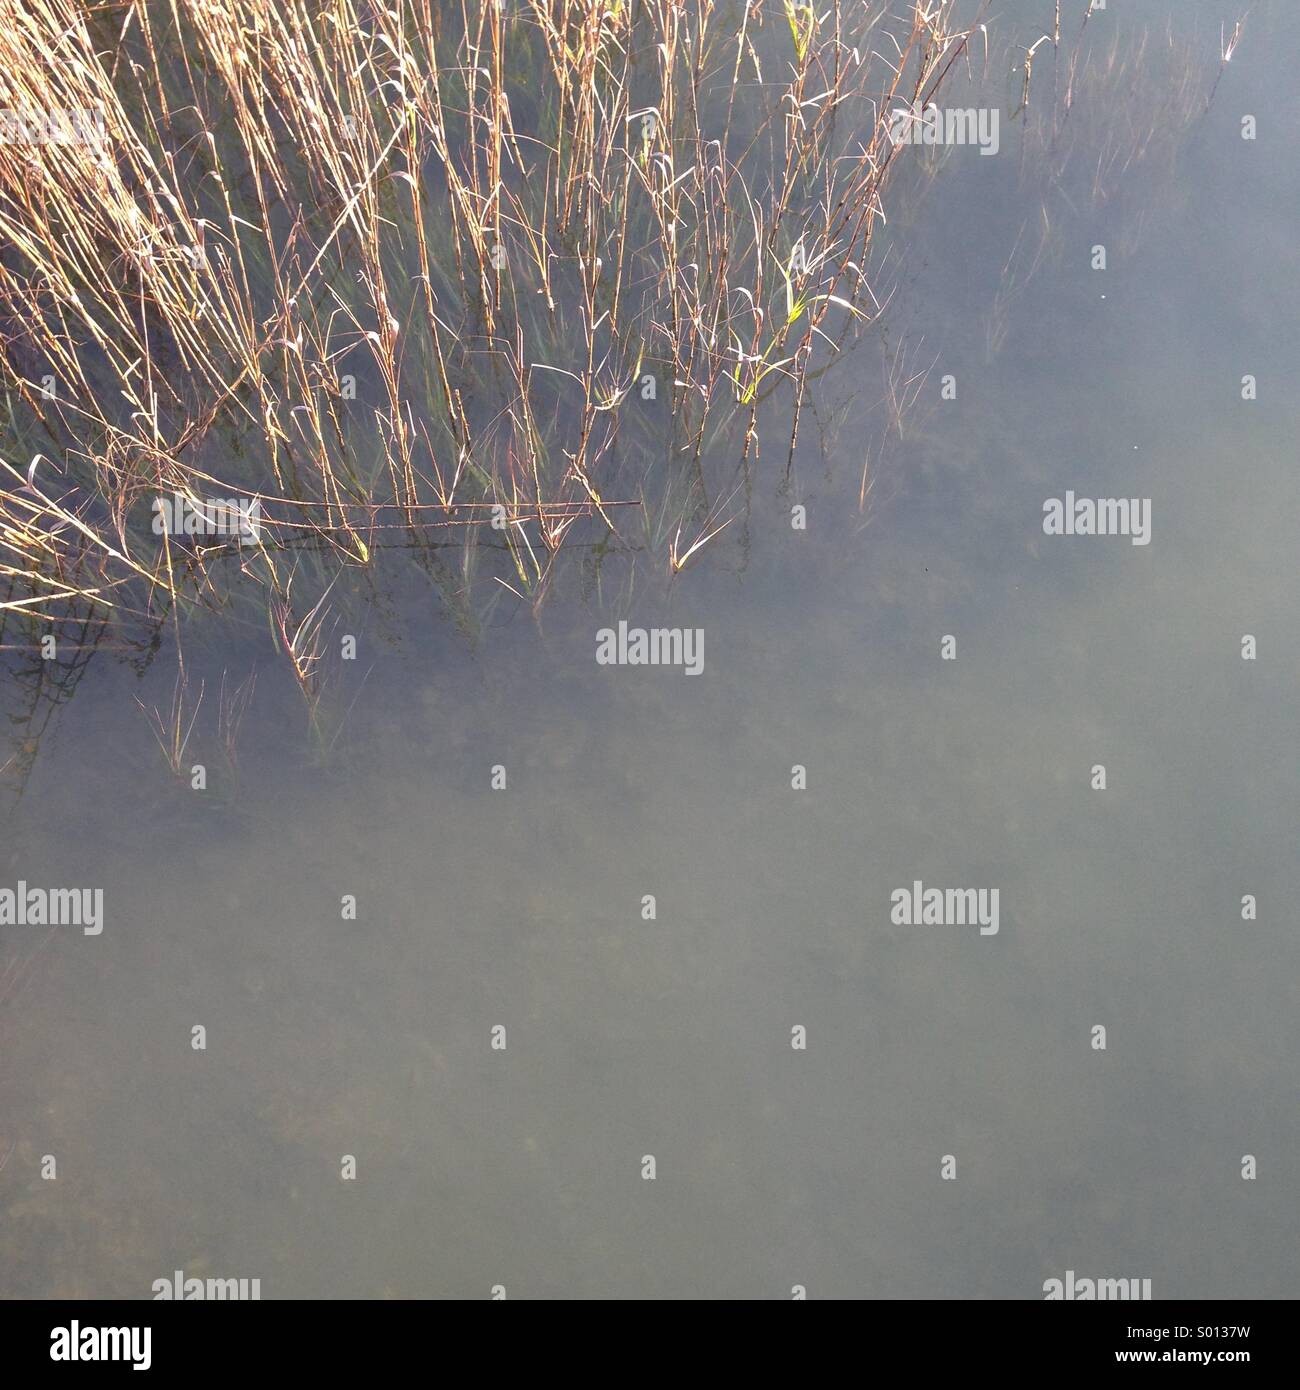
[0,3,1300,1298]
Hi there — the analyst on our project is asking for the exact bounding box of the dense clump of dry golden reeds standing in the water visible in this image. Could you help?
[0,0,969,639]
